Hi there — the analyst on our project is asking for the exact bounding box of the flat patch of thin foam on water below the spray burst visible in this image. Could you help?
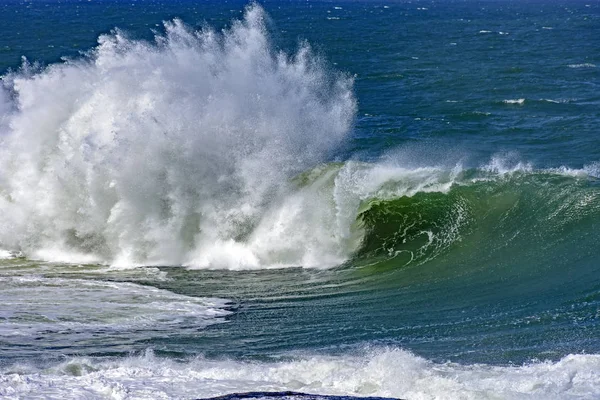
[0,275,230,348]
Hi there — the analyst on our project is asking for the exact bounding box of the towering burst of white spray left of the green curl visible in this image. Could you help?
[0,5,356,268]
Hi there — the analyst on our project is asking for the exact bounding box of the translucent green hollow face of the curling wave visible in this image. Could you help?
[355,170,600,268]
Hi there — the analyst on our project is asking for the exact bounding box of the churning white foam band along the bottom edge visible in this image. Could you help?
[0,349,600,400]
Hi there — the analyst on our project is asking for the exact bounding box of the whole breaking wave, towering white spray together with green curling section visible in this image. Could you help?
[0,5,598,269]
